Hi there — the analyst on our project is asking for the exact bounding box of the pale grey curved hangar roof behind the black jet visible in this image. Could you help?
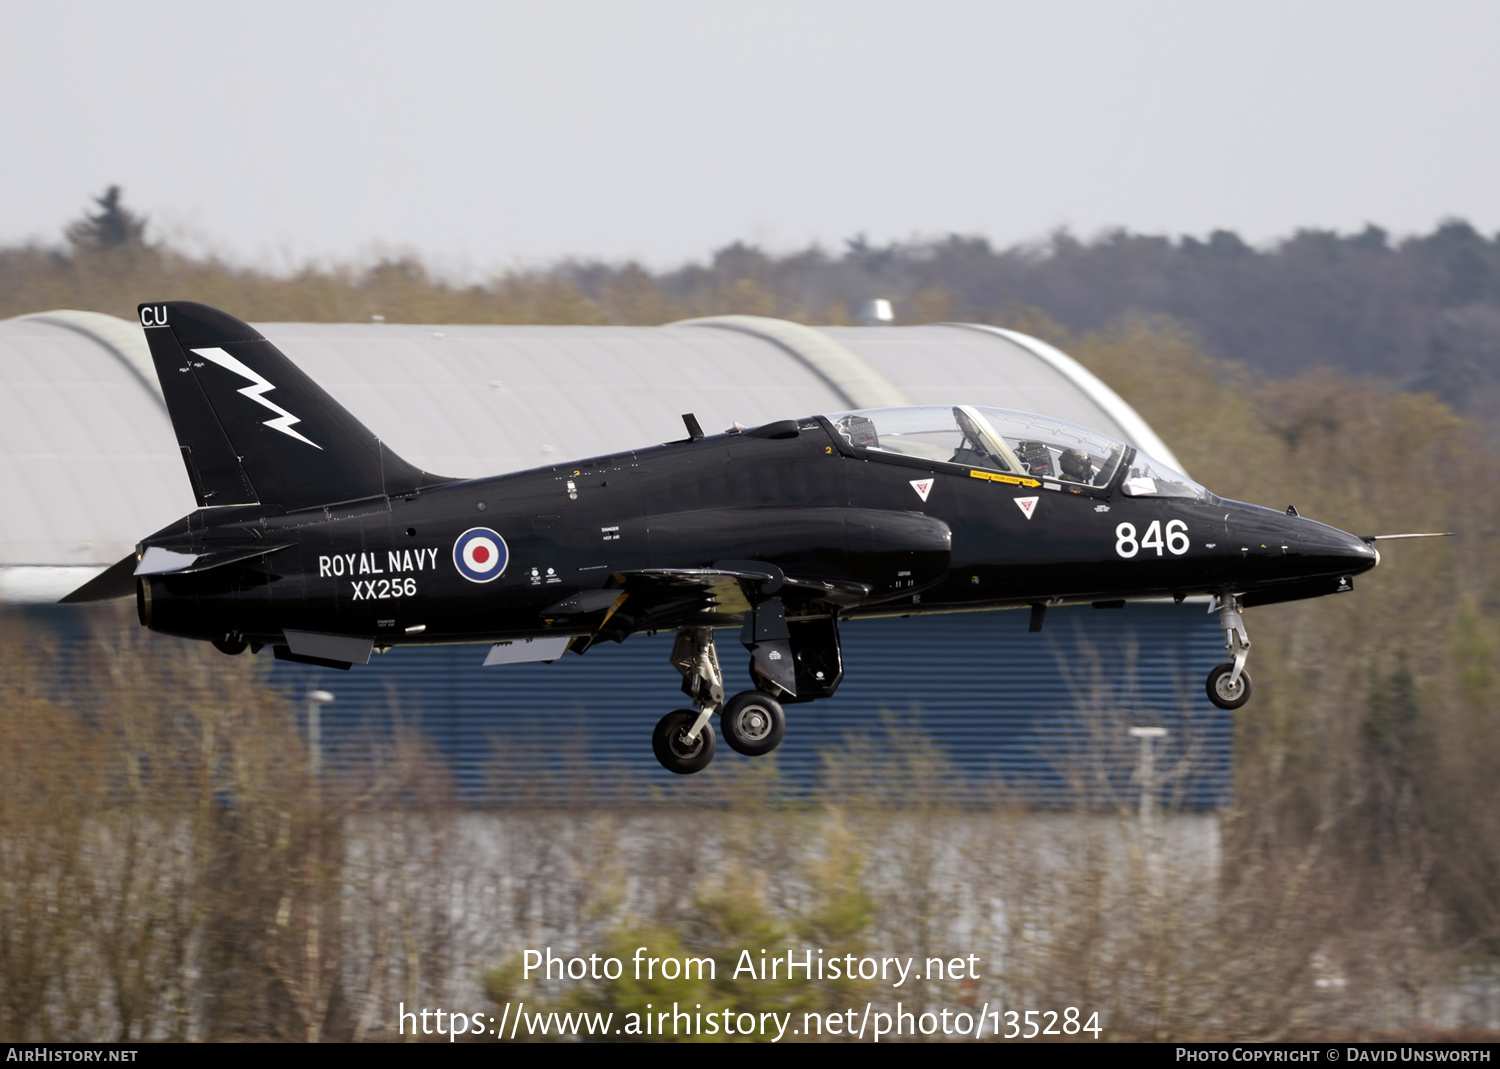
[0,312,1176,601]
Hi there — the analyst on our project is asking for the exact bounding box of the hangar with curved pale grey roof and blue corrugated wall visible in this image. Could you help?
[0,310,1230,810]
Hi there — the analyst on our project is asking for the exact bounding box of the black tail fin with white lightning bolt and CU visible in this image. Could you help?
[138,301,449,510]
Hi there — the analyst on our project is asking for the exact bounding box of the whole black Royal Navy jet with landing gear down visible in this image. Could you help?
[65,301,1416,774]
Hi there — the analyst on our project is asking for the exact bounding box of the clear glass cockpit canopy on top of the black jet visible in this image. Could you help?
[827,405,1208,498]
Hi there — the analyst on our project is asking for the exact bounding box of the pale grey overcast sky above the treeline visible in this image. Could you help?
[0,0,1500,271]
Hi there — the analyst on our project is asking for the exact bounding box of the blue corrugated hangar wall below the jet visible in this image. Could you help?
[272,603,1233,810]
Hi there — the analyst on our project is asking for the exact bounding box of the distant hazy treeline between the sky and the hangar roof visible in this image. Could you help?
[0,187,1500,415]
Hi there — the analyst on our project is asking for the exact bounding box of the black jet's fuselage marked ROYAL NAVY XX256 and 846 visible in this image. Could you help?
[138,418,1376,646]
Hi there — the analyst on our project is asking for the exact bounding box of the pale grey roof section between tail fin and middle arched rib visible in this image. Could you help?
[258,322,842,477]
